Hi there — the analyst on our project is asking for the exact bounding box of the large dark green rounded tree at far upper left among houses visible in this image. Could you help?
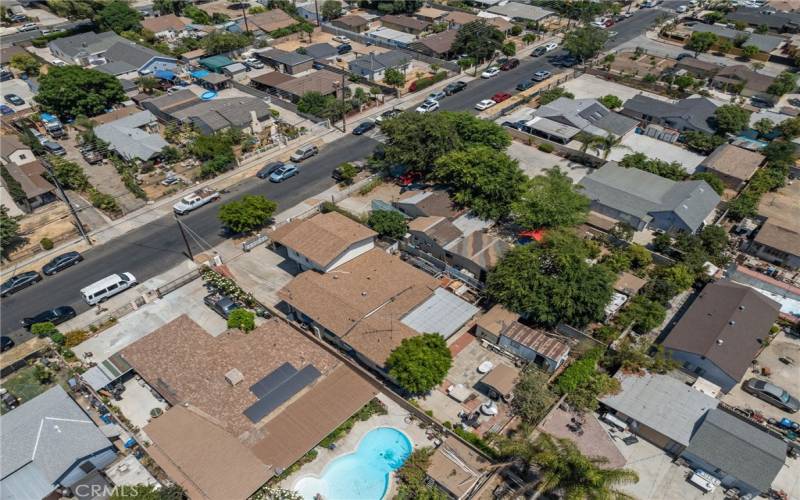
[35,65,127,118]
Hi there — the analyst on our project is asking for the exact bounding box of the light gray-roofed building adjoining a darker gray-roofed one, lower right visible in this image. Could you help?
[600,371,719,454]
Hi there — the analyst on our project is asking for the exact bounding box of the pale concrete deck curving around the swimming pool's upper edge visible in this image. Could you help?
[280,393,434,498]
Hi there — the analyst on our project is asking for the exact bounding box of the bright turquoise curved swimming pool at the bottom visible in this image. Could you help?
[294,427,412,500]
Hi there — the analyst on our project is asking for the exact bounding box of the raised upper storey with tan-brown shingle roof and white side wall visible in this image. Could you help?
[268,212,378,273]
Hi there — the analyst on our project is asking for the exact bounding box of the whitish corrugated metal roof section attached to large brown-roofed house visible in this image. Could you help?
[401,288,478,339]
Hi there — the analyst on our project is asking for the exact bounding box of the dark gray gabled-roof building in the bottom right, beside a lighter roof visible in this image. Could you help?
[681,409,786,498]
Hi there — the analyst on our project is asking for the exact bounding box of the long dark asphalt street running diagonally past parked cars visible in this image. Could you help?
[0,4,683,343]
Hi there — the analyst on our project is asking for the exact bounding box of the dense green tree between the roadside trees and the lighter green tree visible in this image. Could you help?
[433,145,527,219]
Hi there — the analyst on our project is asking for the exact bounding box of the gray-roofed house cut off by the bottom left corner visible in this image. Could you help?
[0,385,117,499]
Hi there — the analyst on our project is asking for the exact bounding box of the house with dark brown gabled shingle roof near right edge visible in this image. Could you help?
[663,281,780,393]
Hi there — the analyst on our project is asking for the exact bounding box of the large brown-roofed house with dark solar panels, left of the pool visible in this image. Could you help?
[121,315,377,500]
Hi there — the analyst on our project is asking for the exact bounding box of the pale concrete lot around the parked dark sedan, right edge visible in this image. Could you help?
[722,333,800,420]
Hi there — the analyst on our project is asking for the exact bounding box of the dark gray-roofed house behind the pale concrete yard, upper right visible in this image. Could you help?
[621,94,717,134]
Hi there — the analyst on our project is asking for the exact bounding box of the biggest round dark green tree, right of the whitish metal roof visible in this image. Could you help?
[486,231,616,327]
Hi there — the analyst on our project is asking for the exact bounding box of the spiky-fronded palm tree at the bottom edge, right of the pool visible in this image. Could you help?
[495,433,639,500]
